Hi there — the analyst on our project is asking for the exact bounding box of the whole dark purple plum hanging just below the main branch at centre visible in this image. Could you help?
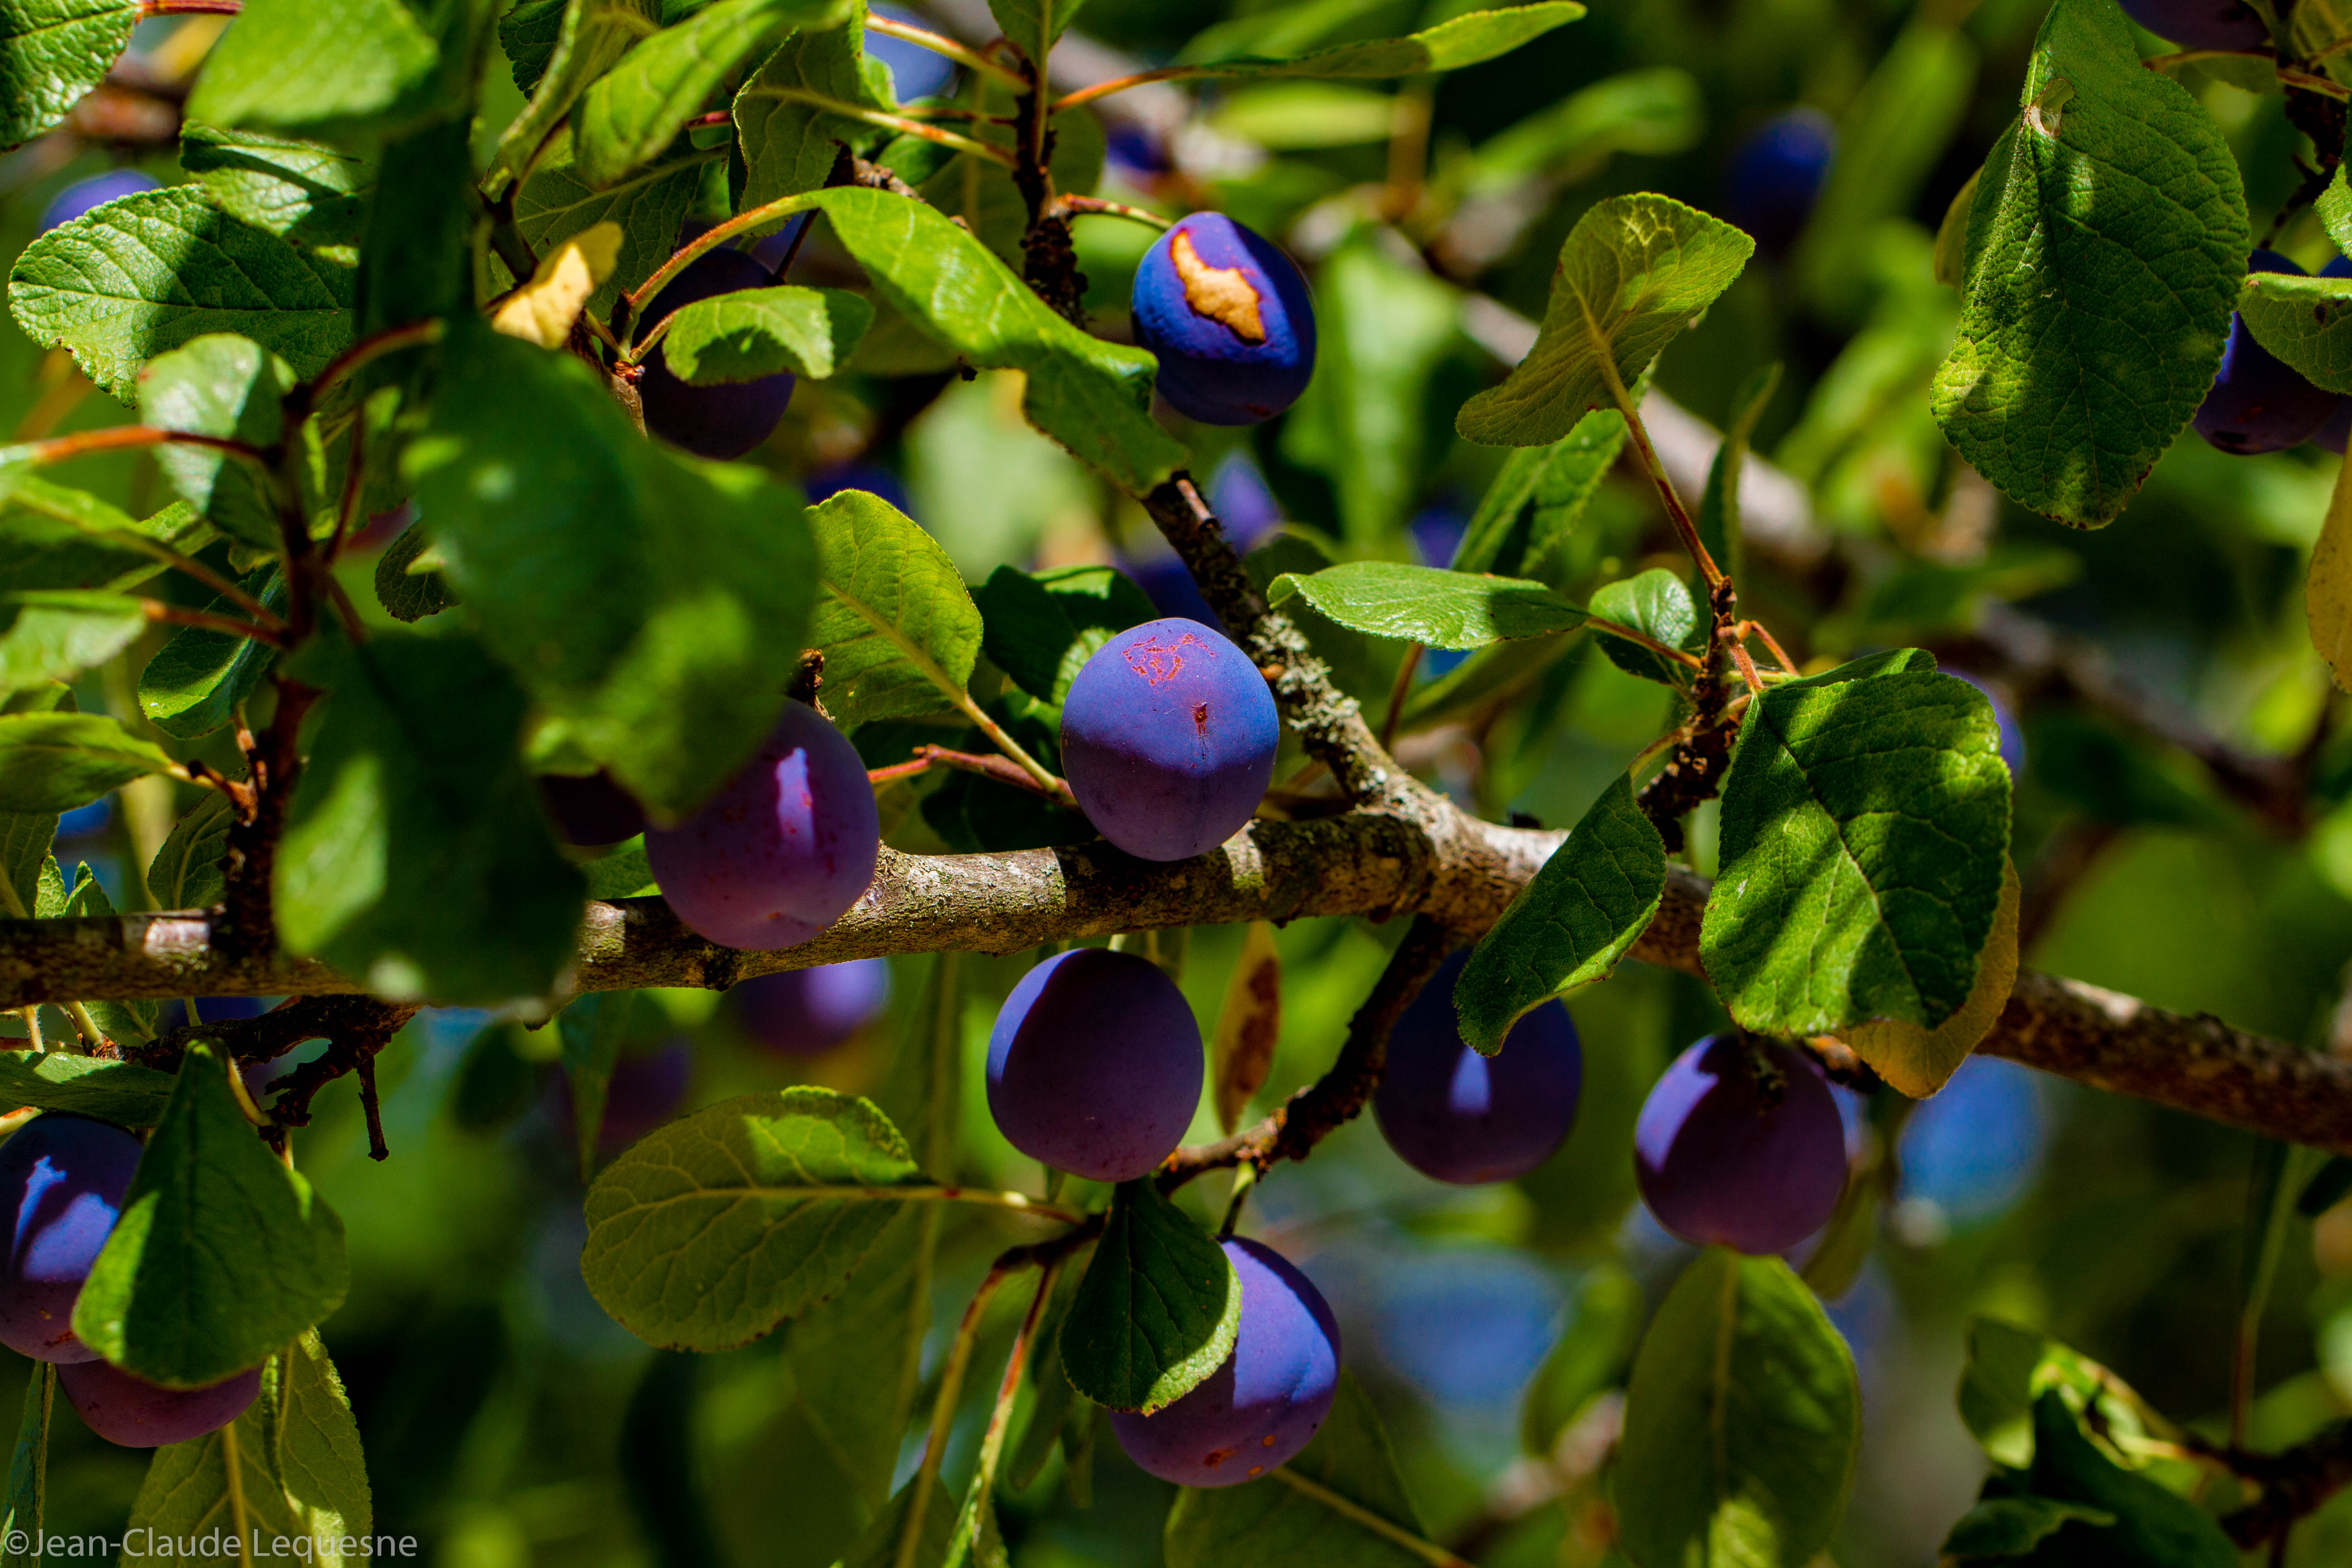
[988,947,1202,1182]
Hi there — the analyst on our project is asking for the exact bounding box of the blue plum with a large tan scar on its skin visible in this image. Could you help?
[1134,211,1315,426]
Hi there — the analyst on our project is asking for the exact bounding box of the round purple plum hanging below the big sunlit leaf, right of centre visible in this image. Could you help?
[1632,1034,1846,1255]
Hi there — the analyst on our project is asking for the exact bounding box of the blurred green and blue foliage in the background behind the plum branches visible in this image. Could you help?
[14,0,2352,1568]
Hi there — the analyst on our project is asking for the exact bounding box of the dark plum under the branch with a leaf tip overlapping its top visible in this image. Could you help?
[1371,950,1585,1187]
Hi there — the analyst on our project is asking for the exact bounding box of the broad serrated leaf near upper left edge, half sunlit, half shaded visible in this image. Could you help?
[10,186,357,402]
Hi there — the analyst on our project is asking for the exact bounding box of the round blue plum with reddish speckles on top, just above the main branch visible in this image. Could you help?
[1061,616,1282,860]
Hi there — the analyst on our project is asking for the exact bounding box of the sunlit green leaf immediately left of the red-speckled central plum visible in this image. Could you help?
[809,489,981,724]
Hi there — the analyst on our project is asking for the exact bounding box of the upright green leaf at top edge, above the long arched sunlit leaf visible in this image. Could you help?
[734,0,898,211]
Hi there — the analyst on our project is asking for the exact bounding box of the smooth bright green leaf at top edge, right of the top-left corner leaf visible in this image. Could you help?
[188,0,440,132]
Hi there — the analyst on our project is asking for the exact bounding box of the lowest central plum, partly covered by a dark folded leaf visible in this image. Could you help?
[1110,1236,1338,1486]
